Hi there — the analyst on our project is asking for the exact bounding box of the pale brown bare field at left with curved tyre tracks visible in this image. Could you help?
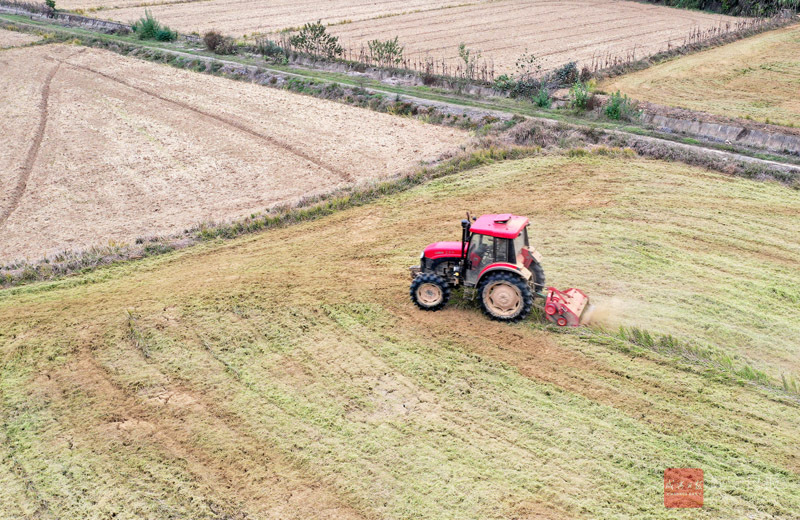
[0,45,468,262]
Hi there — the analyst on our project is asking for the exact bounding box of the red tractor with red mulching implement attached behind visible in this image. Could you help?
[411,213,591,326]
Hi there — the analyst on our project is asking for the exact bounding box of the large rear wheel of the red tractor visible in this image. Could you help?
[478,271,533,322]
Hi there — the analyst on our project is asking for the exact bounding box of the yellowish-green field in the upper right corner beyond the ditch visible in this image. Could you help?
[601,25,800,126]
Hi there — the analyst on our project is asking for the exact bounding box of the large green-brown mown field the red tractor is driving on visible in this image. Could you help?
[0,156,800,519]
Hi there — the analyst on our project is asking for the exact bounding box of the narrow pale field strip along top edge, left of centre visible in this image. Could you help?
[90,0,486,36]
